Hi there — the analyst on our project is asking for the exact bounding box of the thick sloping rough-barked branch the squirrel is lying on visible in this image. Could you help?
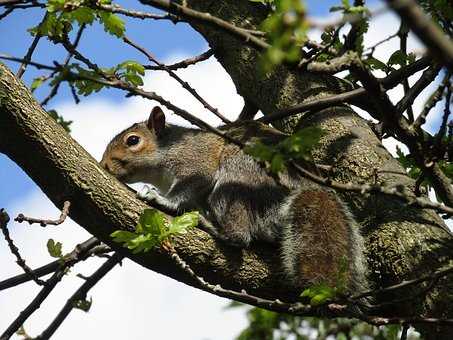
[0,64,308,306]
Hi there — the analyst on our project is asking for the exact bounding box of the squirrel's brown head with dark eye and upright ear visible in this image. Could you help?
[100,106,165,183]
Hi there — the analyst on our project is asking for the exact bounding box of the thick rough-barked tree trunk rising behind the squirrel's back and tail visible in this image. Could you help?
[160,0,453,339]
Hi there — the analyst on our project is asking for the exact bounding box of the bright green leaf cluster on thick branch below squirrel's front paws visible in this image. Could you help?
[111,209,198,254]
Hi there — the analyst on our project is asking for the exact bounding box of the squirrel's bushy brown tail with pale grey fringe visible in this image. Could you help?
[281,189,366,291]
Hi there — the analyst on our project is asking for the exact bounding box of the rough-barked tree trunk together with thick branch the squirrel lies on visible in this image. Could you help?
[0,0,453,339]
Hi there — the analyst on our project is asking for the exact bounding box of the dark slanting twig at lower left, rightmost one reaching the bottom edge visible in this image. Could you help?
[35,253,124,340]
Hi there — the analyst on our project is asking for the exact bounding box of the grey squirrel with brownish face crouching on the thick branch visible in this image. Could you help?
[101,106,366,292]
